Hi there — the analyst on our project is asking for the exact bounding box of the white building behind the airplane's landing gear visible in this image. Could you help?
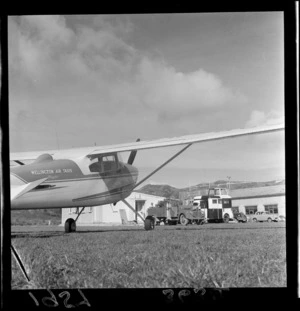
[61,191,165,225]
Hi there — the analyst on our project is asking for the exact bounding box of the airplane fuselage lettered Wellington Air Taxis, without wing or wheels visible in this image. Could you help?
[10,153,138,210]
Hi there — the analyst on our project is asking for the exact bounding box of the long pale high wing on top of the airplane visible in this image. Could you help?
[10,124,284,161]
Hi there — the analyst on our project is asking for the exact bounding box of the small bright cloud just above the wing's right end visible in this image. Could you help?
[245,110,284,128]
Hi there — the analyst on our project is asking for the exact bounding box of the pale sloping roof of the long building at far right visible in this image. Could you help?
[229,185,285,199]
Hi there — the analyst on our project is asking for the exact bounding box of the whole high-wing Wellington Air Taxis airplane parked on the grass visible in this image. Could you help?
[10,124,284,233]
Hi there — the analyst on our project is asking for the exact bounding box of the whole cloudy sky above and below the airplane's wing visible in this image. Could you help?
[8,12,285,187]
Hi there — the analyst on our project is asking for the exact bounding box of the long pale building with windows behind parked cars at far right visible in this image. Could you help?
[229,185,285,216]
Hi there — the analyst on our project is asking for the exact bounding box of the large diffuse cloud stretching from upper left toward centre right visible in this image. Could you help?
[9,16,246,118]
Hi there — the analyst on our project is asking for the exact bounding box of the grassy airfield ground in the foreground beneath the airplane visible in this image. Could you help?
[12,223,286,289]
